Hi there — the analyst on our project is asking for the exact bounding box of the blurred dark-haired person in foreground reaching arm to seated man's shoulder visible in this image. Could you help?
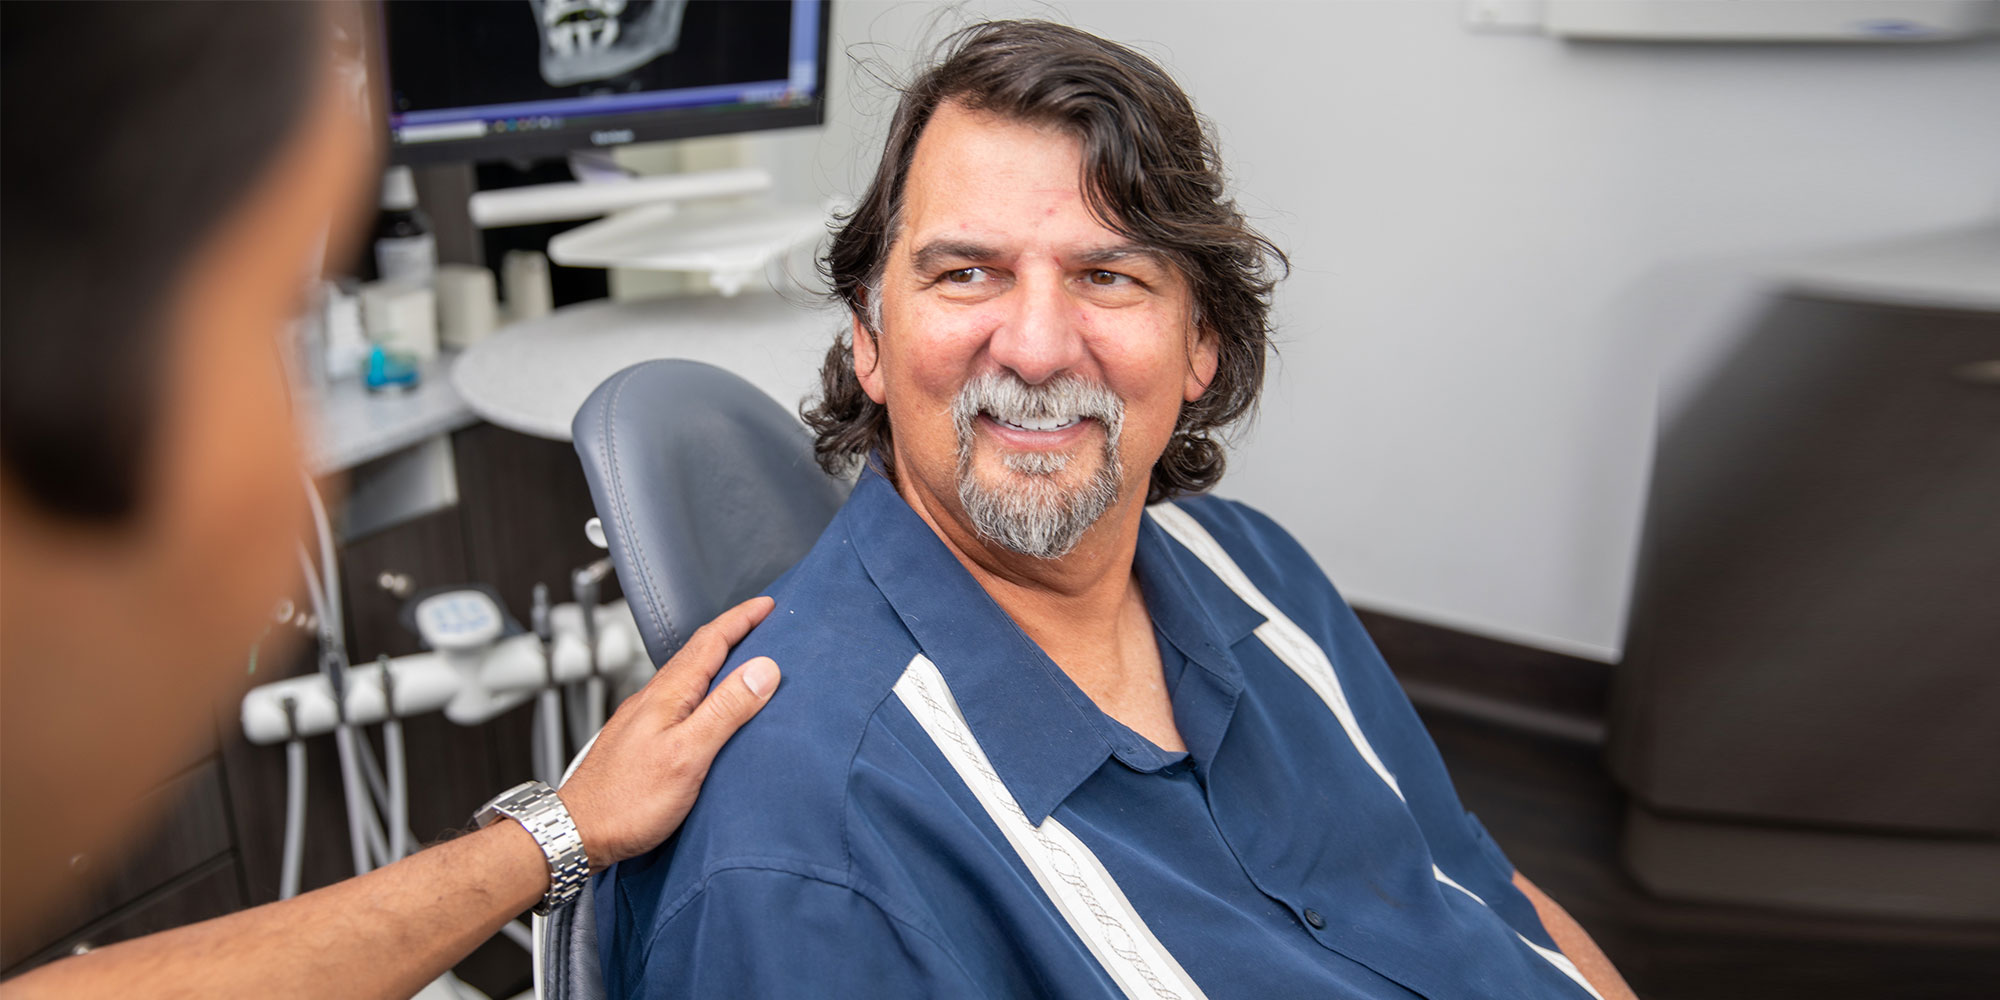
[0,4,778,998]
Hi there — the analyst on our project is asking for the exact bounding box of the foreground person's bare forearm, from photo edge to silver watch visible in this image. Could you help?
[4,822,548,1000]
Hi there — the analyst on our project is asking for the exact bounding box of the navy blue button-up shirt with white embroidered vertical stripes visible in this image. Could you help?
[596,474,1588,998]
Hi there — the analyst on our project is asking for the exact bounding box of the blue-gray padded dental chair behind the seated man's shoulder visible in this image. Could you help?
[534,360,850,1000]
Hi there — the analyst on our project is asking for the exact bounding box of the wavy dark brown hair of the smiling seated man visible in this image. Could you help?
[800,20,1288,502]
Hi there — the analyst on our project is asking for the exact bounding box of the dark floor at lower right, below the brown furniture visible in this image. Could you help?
[1424,710,2000,1000]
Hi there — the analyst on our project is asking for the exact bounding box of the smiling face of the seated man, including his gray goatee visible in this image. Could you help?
[854,104,1216,558]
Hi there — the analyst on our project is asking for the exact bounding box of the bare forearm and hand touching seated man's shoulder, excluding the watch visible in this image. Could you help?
[0,598,778,1000]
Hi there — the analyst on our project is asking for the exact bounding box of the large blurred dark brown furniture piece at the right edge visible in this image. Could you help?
[1610,298,2000,926]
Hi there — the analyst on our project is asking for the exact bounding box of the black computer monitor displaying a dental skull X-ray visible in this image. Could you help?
[382,0,828,164]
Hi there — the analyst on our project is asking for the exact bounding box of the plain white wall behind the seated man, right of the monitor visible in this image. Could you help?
[748,0,2000,660]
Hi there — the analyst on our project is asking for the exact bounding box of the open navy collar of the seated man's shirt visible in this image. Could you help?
[840,468,1264,826]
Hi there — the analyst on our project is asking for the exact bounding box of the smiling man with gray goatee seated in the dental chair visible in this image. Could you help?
[596,22,1628,998]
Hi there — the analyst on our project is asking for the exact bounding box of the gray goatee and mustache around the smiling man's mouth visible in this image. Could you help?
[952,372,1124,560]
